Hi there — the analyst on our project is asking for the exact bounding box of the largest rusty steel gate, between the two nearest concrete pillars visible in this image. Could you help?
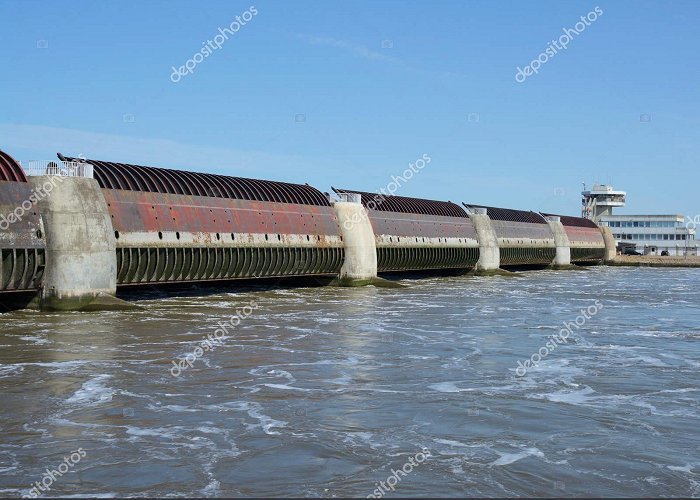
[60,156,344,286]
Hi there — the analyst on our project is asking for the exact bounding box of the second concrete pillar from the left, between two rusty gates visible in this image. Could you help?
[333,193,377,286]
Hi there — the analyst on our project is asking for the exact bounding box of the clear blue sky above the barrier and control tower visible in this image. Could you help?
[0,0,700,215]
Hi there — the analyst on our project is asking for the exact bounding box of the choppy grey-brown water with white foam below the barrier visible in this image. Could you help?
[0,268,700,497]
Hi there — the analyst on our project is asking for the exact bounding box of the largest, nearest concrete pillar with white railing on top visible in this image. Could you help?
[29,176,117,310]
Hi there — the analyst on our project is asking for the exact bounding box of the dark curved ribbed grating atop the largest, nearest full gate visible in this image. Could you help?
[58,153,330,206]
